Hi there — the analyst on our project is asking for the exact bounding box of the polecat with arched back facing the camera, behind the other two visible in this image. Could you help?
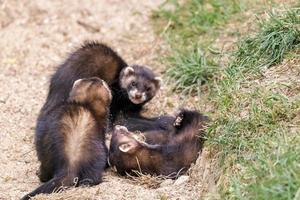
[40,42,160,121]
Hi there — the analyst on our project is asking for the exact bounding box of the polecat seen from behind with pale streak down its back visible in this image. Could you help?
[23,77,112,200]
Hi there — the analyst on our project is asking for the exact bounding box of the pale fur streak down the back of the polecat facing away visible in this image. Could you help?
[63,109,95,167]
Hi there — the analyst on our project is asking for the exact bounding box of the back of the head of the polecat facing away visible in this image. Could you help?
[68,77,112,105]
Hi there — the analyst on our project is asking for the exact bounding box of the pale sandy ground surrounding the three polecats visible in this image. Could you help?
[0,0,217,199]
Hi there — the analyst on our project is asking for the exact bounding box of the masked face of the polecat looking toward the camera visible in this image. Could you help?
[120,65,161,104]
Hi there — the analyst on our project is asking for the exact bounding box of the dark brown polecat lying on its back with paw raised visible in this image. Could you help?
[109,110,208,178]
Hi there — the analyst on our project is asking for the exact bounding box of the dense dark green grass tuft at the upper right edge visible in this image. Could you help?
[226,10,300,79]
